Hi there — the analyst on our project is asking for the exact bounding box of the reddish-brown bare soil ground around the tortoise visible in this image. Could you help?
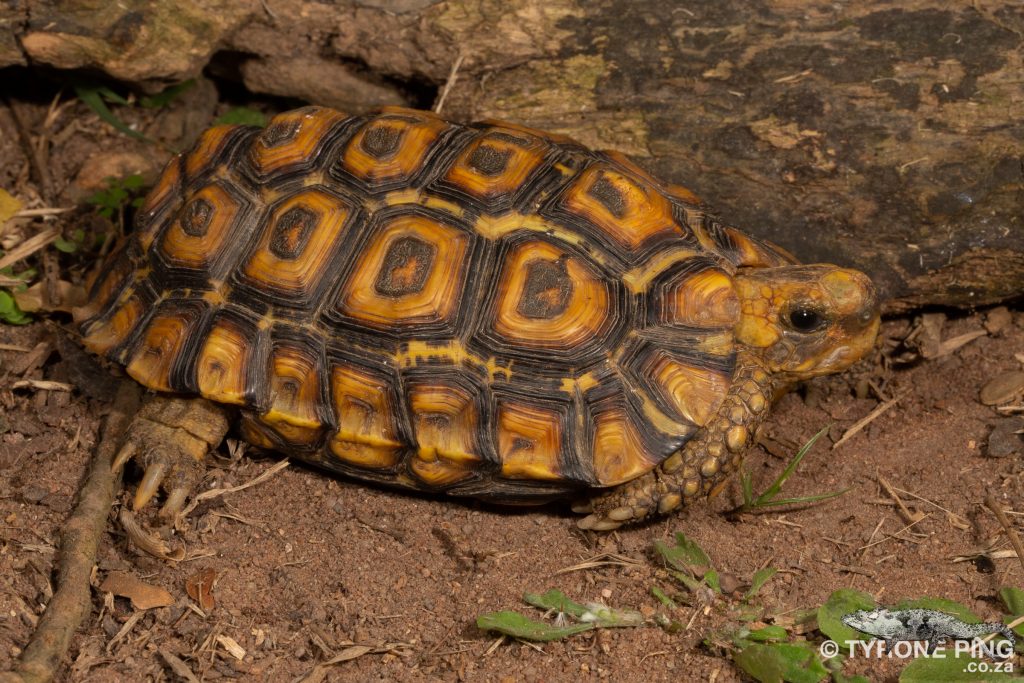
[0,74,1024,682]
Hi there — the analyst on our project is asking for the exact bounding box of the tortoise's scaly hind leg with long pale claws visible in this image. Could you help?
[114,395,227,517]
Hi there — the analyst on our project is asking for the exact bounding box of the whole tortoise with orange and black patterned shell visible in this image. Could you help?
[75,108,879,529]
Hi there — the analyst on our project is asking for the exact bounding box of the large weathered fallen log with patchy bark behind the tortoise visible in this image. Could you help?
[8,0,1024,310]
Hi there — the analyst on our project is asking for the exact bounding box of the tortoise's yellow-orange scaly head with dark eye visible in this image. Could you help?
[735,264,879,381]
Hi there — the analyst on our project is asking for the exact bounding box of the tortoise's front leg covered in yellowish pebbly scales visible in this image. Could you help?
[579,353,775,531]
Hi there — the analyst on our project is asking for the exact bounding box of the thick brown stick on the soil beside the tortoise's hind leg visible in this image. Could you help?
[0,382,140,683]
